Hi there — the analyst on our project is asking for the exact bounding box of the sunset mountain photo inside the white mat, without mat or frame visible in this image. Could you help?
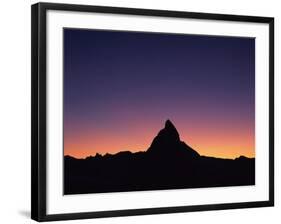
[63,28,255,194]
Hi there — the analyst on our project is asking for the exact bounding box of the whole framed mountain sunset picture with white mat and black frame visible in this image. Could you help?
[31,3,274,221]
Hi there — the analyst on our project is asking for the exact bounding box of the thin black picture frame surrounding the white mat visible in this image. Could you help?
[31,3,274,221]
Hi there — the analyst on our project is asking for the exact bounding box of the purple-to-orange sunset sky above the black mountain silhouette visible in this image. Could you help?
[64,29,255,158]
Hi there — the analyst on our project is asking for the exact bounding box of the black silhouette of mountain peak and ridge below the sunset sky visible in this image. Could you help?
[64,120,255,194]
